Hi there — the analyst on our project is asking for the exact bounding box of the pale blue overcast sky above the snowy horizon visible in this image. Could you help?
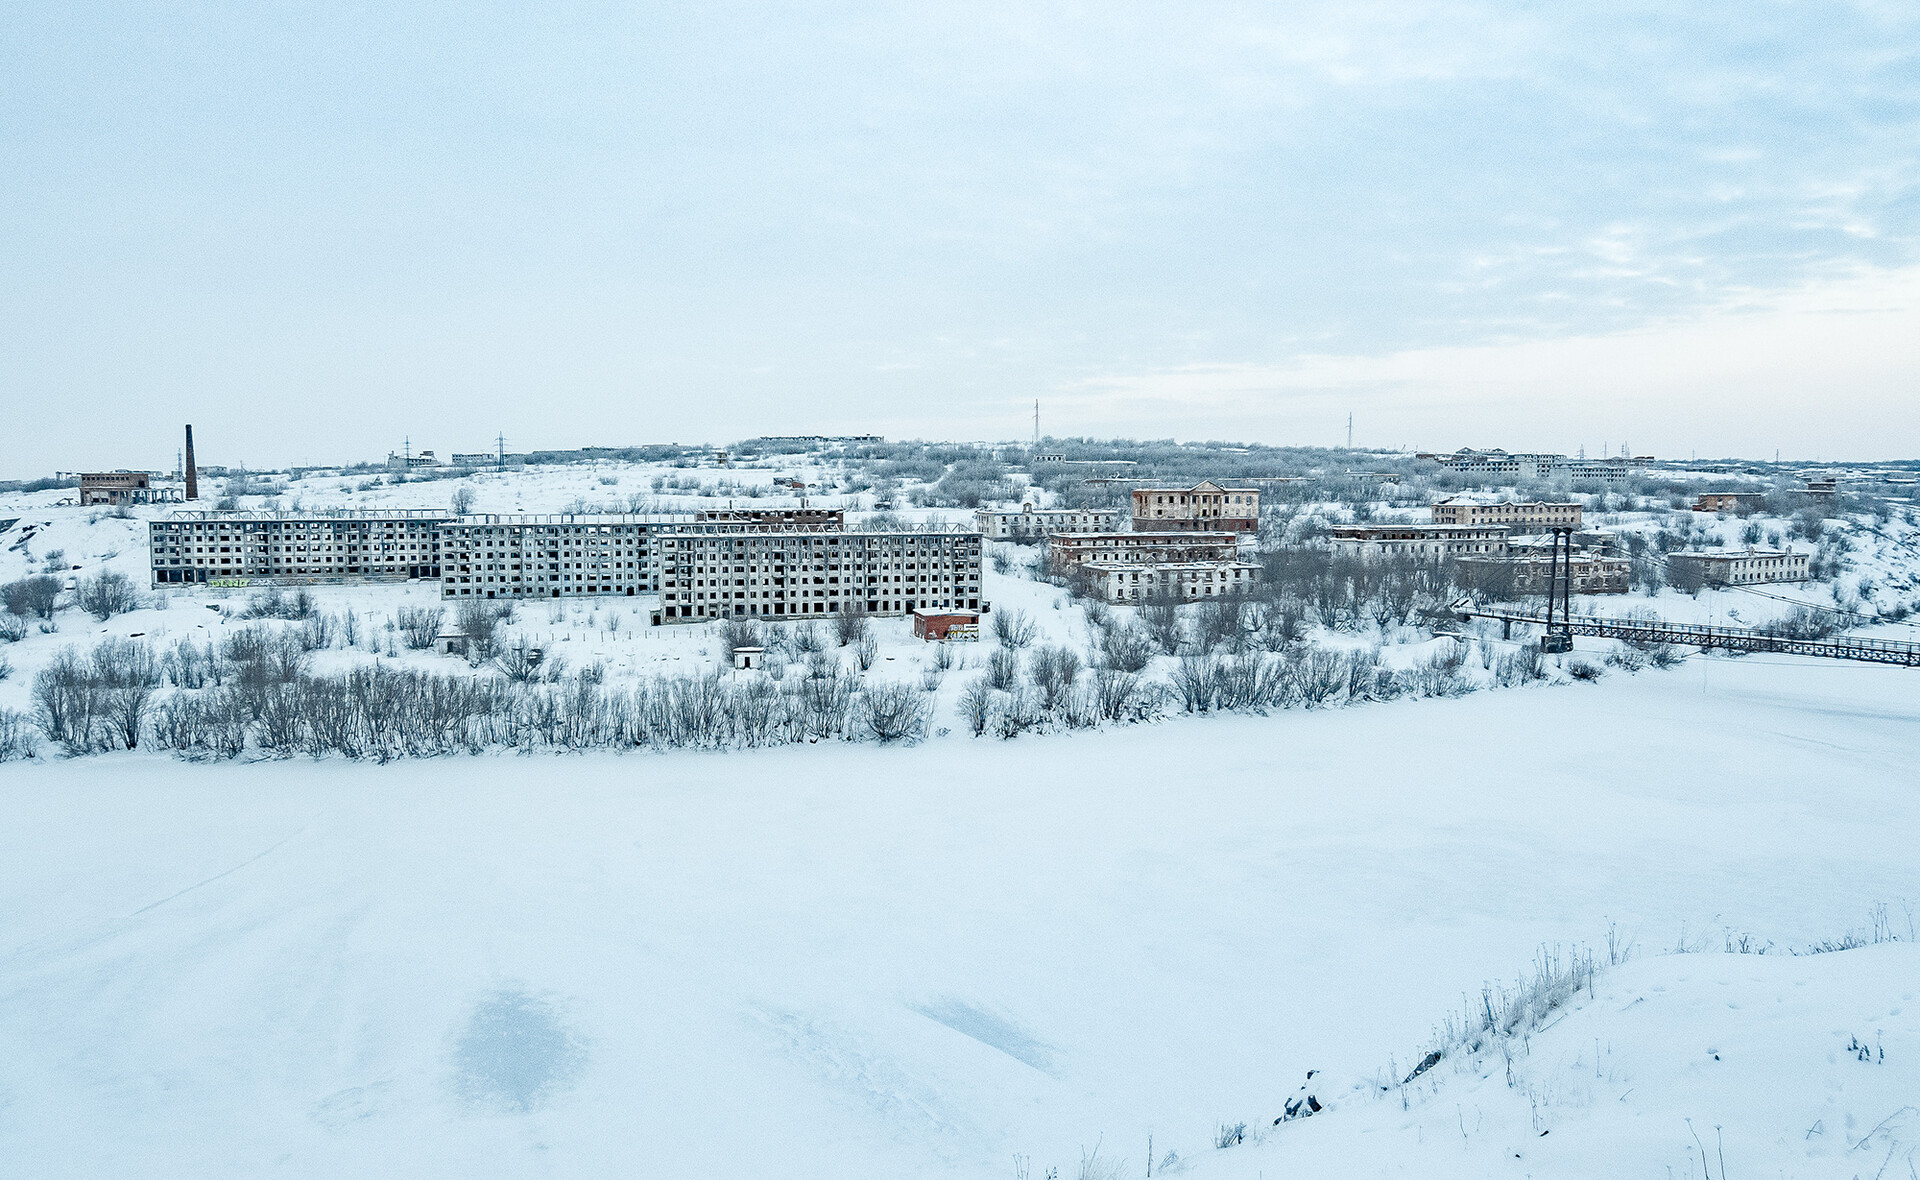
[0,0,1920,478]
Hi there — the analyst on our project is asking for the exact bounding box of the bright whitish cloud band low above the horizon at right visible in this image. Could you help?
[1048,267,1920,459]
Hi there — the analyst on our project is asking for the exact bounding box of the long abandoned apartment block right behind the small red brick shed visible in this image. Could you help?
[659,531,981,624]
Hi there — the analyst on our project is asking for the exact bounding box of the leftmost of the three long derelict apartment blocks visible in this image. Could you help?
[148,508,449,585]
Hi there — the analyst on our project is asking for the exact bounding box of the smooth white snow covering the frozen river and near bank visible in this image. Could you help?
[0,656,1920,1180]
